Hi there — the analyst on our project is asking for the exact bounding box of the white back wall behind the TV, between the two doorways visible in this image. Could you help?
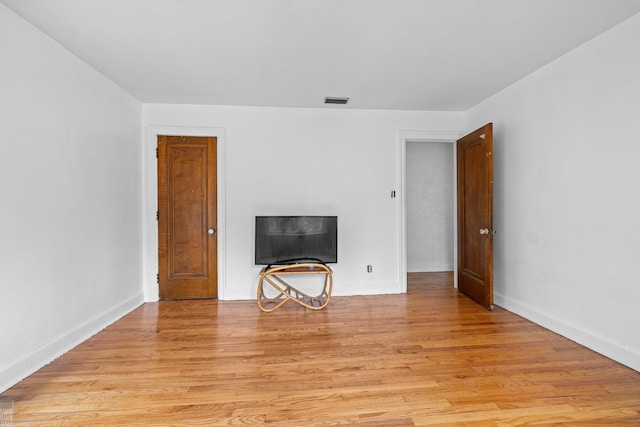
[143,105,462,300]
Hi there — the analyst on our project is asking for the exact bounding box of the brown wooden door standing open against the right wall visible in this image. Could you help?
[457,123,494,309]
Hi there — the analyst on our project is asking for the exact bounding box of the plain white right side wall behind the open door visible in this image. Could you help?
[466,10,640,370]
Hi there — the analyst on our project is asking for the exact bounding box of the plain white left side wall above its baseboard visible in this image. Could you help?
[0,5,142,391]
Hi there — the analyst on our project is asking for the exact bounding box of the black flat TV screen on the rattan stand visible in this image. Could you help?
[255,216,338,265]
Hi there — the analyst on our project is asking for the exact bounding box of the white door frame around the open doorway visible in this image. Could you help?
[398,131,464,293]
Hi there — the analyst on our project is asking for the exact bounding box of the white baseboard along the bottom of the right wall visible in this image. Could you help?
[493,293,640,372]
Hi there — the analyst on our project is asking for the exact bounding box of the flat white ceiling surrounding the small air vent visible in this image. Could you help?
[5,0,640,111]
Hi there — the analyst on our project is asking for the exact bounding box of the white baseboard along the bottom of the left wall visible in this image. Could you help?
[0,293,143,393]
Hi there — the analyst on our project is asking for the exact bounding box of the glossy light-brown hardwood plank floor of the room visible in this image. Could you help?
[0,273,640,426]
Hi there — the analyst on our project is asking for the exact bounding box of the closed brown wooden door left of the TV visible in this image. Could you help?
[158,136,218,300]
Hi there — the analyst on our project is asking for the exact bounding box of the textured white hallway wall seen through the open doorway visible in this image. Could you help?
[405,141,455,272]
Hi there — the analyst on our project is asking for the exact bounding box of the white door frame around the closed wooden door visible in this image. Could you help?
[142,125,227,302]
